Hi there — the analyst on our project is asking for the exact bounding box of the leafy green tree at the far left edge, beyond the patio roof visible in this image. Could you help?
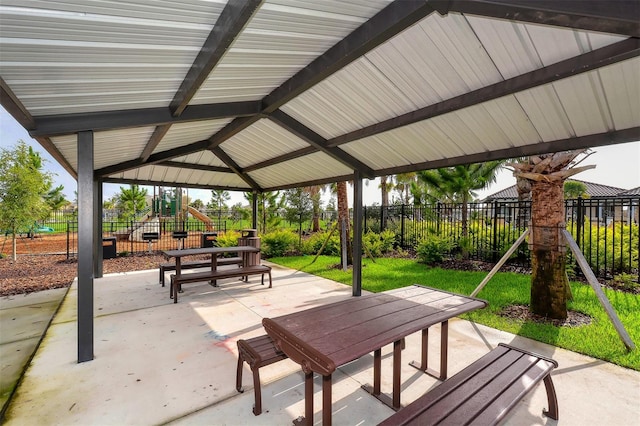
[0,140,53,260]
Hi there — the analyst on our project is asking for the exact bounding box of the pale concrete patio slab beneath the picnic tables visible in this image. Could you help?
[3,265,640,425]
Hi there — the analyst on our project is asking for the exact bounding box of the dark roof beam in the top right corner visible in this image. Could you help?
[429,0,640,37]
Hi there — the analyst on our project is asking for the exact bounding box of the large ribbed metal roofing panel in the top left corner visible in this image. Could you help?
[0,0,224,116]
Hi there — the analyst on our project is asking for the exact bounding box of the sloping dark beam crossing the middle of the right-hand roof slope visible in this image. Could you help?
[328,38,640,150]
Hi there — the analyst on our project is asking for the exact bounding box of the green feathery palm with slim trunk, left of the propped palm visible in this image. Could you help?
[418,161,504,258]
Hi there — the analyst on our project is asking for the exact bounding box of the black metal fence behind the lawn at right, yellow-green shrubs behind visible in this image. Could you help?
[364,197,640,278]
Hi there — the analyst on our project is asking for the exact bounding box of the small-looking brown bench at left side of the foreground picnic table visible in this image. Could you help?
[236,334,287,416]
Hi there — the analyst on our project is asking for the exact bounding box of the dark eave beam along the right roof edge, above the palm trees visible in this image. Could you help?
[377,127,640,176]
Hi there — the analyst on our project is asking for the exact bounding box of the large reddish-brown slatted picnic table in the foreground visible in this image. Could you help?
[262,285,488,425]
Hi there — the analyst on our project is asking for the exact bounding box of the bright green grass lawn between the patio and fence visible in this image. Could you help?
[269,256,640,371]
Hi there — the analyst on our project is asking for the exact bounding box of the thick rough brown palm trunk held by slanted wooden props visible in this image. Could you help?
[530,180,569,319]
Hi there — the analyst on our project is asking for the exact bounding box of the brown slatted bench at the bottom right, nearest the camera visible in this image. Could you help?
[379,343,558,426]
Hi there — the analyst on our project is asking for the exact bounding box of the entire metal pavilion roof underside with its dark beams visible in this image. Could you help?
[0,0,640,191]
